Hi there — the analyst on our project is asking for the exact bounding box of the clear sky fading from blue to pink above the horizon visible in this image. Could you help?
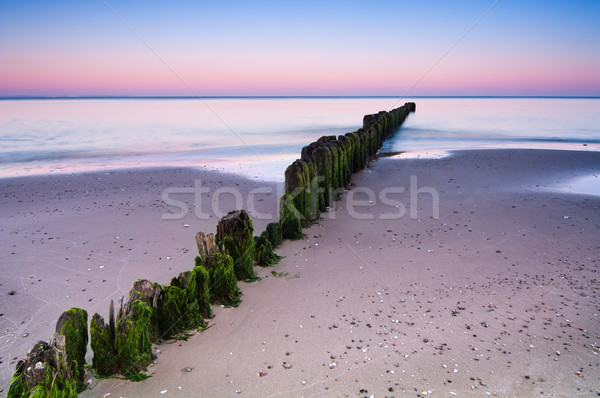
[0,0,600,96]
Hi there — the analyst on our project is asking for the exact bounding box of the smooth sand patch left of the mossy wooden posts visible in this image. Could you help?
[0,168,278,392]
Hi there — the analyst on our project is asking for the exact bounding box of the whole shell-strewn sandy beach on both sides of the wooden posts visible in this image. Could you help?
[0,150,600,397]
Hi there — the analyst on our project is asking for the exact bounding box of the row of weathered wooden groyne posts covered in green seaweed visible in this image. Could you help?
[7,102,415,398]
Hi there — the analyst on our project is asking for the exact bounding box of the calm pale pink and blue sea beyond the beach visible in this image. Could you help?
[0,97,600,181]
